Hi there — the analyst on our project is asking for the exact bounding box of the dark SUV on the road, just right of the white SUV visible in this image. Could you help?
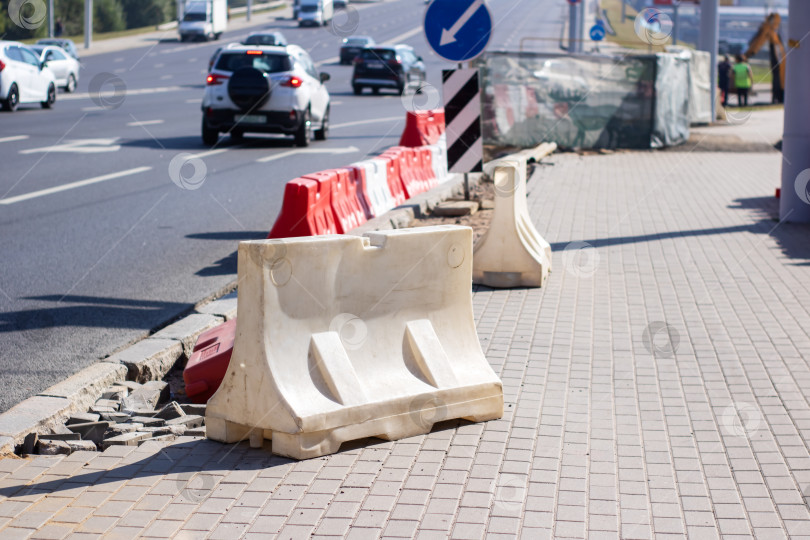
[352,45,425,94]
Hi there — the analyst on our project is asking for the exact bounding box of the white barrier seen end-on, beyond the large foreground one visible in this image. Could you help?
[473,160,551,288]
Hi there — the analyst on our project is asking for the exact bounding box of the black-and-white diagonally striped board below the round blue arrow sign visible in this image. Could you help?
[442,64,484,200]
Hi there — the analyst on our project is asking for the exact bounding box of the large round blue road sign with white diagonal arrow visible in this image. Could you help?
[424,0,492,62]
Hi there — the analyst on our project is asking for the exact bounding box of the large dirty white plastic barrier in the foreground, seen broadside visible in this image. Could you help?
[206,225,503,459]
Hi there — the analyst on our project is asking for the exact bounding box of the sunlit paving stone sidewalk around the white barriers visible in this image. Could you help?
[0,112,810,540]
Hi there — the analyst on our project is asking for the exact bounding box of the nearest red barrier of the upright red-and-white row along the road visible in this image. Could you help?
[267,178,337,238]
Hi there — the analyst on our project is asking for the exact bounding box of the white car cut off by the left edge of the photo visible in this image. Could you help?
[0,41,56,111]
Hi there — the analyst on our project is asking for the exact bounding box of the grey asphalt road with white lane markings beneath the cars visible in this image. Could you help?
[0,0,567,411]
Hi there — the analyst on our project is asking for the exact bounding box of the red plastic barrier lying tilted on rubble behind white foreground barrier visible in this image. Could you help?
[188,318,236,403]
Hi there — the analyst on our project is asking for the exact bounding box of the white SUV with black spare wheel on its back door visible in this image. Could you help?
[202,45,329,146]
